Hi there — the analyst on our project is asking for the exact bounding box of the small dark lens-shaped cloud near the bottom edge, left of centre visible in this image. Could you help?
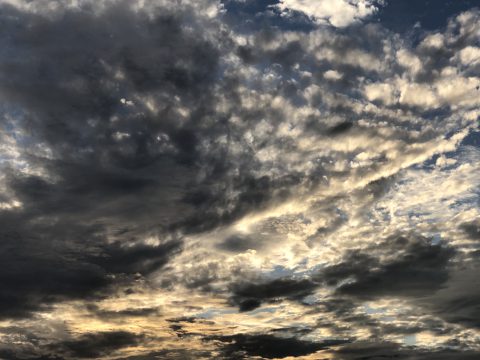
[49,331,143,359]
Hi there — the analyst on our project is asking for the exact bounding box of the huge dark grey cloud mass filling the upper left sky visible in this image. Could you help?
[0,2,225,317]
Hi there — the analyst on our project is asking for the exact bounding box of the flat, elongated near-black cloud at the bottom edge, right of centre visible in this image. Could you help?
[208,334,347,359]
